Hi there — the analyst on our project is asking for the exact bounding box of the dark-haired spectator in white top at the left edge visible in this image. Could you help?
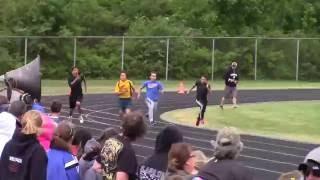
[0,101,27,157]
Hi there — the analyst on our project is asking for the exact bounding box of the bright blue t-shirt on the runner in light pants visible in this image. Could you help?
[142,80,163,101]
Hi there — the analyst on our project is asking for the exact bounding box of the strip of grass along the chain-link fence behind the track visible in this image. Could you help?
[42,80,320,95]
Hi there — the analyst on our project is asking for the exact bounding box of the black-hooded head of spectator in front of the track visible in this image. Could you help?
[155,126,183,153]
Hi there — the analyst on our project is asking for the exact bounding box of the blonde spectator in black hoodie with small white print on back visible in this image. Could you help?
[0,111,48,180]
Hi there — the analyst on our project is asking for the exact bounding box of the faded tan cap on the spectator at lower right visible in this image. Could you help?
[210,127,243,152]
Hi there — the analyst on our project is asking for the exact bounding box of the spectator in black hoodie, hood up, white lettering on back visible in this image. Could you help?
[139,126,183,180]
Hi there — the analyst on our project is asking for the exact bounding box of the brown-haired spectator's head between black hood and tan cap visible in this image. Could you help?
[168,143,195,174]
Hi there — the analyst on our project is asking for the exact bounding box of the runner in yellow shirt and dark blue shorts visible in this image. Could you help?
[115,71,135,116]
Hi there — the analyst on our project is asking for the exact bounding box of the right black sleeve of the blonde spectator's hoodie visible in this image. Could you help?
[29,147,48,180]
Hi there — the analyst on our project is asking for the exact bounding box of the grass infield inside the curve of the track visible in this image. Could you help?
[161,101,320,143]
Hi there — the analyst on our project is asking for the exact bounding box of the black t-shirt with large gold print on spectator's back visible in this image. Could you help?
[101,136,138,180]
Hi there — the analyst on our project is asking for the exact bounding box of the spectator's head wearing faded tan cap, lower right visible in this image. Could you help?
[211,127,243,160]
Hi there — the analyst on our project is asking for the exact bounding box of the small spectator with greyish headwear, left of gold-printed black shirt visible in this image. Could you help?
[79,139,102,180]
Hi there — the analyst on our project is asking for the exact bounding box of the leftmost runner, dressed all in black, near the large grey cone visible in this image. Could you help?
[68,67,87,123]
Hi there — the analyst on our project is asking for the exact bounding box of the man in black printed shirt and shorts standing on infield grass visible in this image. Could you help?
[220,62,239,109]
